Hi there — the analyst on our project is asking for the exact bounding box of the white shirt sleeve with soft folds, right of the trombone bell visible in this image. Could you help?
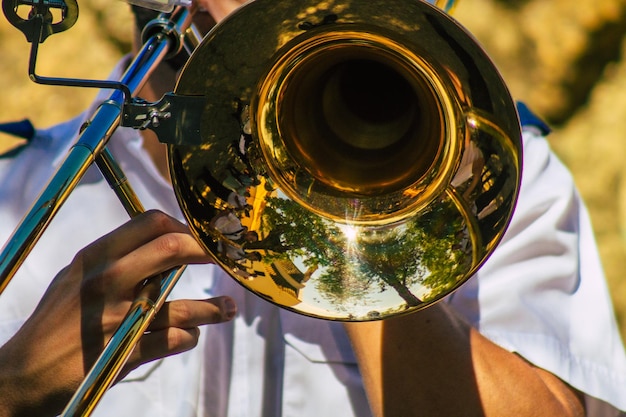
[450,127,626,410]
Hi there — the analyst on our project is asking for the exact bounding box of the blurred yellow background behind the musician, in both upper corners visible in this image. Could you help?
[0,0,626,336]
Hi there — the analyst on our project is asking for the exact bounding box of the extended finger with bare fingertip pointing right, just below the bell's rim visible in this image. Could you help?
[149,296,237,331]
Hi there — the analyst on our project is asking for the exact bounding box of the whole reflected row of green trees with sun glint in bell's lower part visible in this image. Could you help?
[250,192,472,309]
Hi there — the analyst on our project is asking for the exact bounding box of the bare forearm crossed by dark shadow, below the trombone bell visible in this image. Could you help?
[346,303,582,417]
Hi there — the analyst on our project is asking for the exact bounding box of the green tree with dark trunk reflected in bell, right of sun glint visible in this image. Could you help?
[332,194,471,306]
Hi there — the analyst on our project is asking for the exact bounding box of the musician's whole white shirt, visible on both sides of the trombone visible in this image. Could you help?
[0,80,626,417]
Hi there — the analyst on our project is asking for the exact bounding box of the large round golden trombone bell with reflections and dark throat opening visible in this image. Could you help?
[169,0,521,320]
